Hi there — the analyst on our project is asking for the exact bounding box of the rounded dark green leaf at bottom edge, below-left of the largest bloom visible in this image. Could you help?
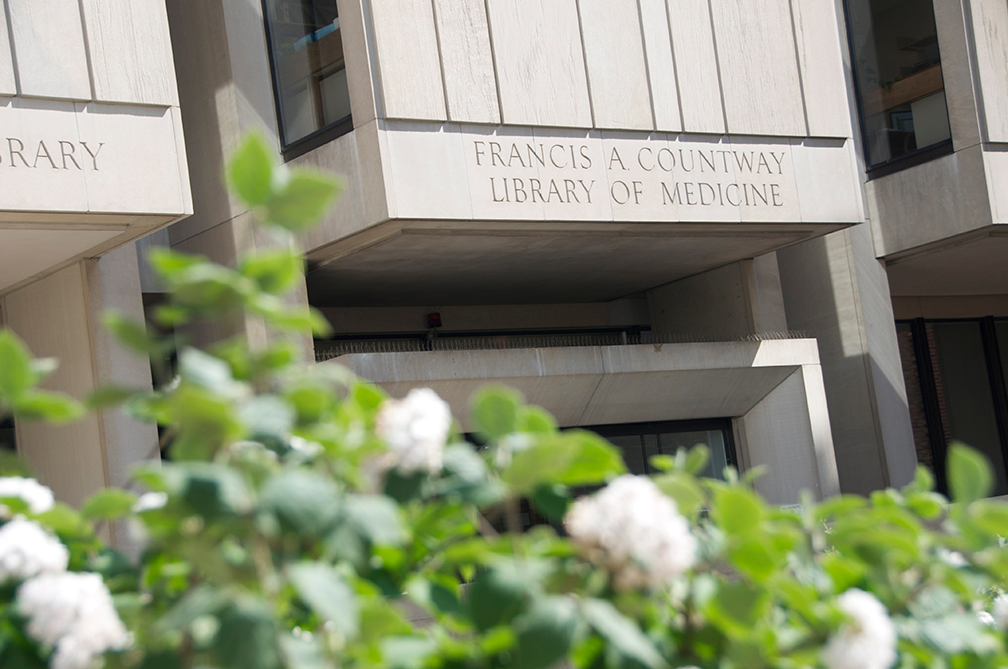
[512,596,578,669]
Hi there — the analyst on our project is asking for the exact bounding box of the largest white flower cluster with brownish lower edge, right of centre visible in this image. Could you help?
[563,475,697,588]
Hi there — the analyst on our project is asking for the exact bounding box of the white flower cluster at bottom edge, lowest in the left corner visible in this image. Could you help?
[17,571,131,669]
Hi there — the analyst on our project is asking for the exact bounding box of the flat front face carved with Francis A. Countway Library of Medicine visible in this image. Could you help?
[381,122,862,224]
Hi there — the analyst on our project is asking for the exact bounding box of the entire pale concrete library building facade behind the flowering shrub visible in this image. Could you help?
[0,0,1008,519]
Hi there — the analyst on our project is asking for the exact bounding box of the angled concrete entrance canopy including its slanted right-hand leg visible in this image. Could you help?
[322,340,840,503]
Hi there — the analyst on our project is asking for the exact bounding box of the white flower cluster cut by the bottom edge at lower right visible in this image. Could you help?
[823,588,896,669]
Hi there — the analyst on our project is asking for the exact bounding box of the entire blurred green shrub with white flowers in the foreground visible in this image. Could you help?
[0,140,1008,669]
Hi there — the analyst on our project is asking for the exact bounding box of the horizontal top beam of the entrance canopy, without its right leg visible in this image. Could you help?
[320,340,825,429]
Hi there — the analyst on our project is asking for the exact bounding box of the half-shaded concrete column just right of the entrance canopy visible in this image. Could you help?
[777,225,916,494]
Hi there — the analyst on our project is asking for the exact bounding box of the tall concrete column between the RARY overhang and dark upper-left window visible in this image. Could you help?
[161,0,312,361]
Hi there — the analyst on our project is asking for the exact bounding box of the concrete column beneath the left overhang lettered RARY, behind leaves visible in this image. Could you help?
[3,244,159,548]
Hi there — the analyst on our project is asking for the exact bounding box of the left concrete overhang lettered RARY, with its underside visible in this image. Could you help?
[0,98,193,294]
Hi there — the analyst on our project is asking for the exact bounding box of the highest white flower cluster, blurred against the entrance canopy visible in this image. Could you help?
[375,388,452,475]
